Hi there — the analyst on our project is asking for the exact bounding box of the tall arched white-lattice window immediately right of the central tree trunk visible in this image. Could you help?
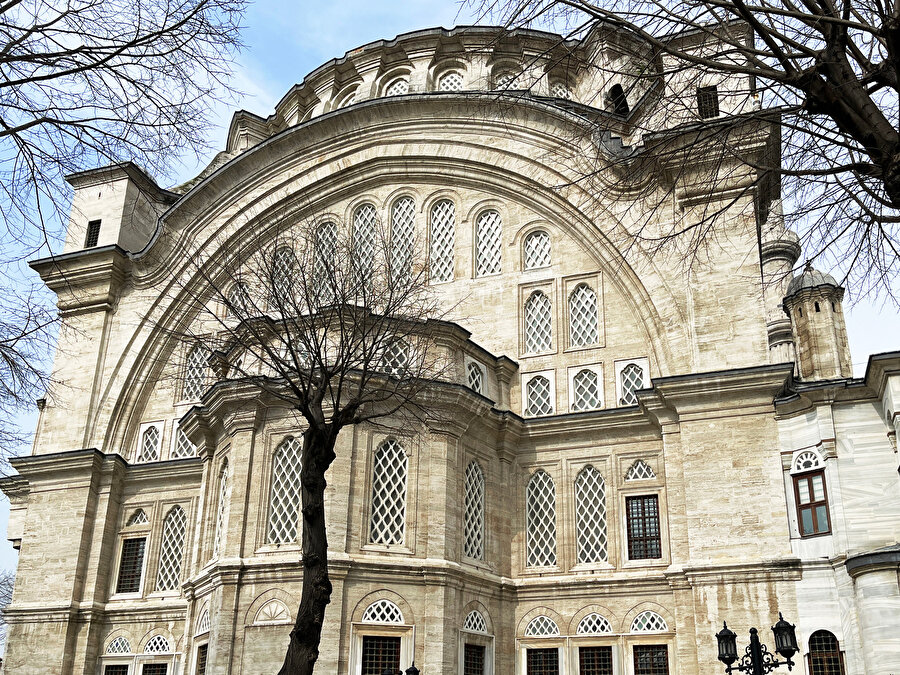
[369,438,409,545]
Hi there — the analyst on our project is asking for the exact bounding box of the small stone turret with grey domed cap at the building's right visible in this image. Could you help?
[783,263,853,380]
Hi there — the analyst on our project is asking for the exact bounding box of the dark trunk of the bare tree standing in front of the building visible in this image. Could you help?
[278,424,336,675]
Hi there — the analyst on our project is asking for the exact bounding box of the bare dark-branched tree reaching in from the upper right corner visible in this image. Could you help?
[470,0,900,301]
